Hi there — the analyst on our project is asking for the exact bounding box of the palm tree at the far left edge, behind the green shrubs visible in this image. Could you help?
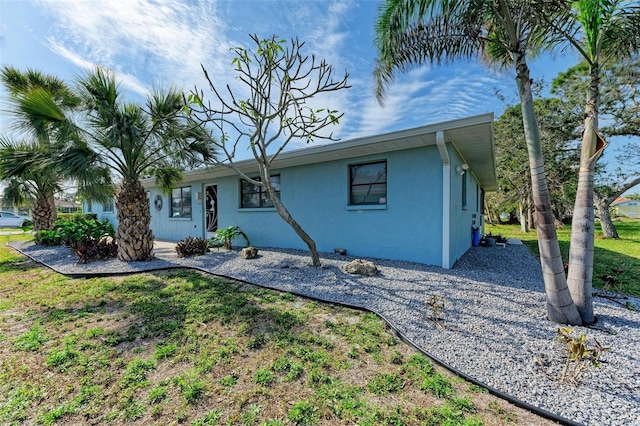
[0,66,79,230]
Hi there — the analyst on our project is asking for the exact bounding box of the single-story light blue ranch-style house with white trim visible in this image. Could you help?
[85,113,497,268]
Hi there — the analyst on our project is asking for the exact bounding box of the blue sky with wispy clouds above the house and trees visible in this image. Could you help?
[0,0,576,146]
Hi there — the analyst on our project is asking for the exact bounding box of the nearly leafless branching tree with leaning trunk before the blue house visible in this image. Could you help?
[191,35,349,266]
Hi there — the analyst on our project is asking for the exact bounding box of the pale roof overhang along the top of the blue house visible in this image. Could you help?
[143,113,498,191]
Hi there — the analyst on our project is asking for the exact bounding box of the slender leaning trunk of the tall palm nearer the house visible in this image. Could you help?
[514,54,582,325]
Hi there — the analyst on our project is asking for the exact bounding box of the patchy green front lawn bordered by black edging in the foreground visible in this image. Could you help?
[0,235,550,425]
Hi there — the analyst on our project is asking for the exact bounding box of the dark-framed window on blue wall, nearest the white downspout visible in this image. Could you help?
[349,161,387,206]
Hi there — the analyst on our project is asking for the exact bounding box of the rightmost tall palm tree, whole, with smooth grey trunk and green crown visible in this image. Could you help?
[546,0,640,324]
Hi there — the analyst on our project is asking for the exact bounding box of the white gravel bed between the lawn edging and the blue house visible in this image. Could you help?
[6,242,640,426]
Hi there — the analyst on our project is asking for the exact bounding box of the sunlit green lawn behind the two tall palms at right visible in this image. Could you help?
[485,219,640,296]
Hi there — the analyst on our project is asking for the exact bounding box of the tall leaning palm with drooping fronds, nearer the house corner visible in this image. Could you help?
[374,0,581,324]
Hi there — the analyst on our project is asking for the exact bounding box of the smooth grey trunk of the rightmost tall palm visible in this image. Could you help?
[567,64,604,324]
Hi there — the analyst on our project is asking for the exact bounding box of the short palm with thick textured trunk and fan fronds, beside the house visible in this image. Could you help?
[71,68,214,261]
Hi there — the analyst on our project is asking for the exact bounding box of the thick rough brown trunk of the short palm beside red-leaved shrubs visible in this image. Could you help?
[116,178,154,262]
